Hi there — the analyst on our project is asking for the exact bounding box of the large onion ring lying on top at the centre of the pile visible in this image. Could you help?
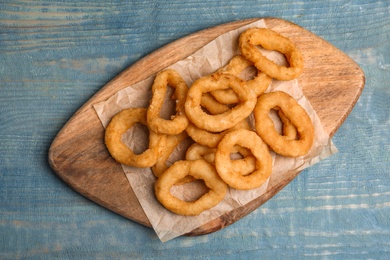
[185,73,256,132]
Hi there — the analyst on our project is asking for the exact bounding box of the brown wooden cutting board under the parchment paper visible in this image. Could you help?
[49,18,365,236]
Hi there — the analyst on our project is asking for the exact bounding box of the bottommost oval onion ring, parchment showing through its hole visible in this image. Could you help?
[155,160,228,216]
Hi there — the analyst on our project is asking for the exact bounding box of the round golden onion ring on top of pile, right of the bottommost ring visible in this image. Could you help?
[215,129,272,190]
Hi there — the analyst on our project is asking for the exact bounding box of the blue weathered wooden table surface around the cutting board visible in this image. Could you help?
[0,0,390,259]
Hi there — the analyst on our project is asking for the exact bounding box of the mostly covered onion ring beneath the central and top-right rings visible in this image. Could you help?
[211,55,272,104]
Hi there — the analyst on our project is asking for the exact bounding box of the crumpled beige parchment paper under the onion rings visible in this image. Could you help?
[94,20,337,242]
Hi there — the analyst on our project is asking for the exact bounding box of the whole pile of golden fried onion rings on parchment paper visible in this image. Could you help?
[105,28,314,216]
